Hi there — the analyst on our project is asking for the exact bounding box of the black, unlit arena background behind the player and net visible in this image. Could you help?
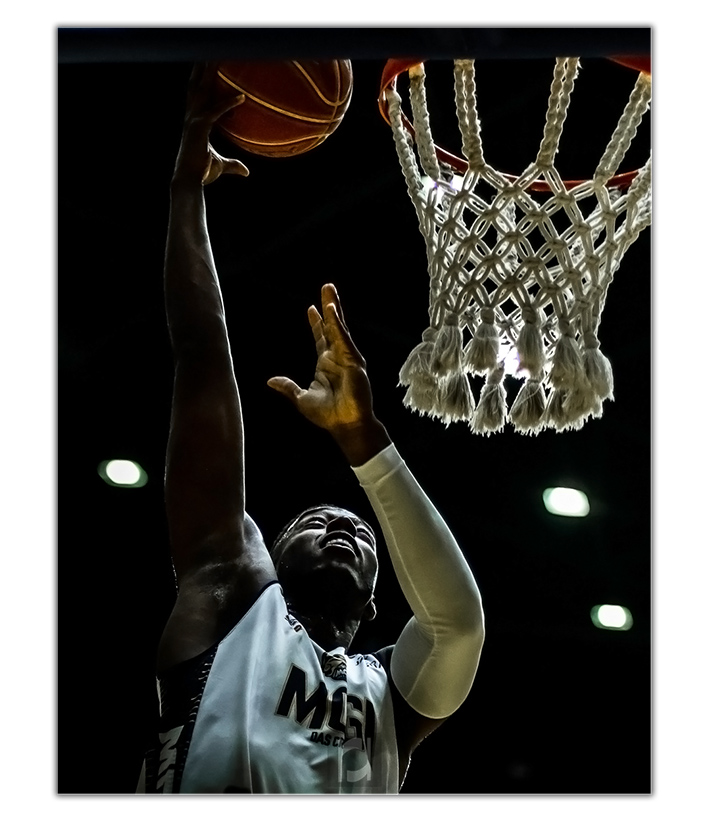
[57,29,651,794]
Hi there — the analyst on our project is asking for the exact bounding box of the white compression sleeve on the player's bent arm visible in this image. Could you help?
[353,445,484,719]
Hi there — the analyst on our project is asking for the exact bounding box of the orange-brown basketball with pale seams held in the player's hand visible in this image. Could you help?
[212,60,352,157]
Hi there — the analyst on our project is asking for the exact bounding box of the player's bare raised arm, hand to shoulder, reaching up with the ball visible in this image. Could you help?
[160,65,275,665]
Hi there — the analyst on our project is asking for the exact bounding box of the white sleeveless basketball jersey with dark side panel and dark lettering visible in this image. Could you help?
[138,582,399,794]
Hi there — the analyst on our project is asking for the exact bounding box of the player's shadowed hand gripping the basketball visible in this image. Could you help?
[173,63,249,185]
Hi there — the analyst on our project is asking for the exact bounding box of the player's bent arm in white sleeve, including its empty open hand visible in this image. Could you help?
[269,285,484,776]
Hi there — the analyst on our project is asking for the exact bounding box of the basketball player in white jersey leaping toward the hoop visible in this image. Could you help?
[138,66,484,793]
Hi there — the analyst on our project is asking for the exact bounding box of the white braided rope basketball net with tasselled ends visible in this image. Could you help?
[386,58,651,434]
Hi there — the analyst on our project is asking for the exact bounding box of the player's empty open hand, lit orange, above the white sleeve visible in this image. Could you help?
[268,284,373,433]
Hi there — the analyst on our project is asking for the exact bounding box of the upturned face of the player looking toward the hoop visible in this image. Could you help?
[278,508,378,592]
